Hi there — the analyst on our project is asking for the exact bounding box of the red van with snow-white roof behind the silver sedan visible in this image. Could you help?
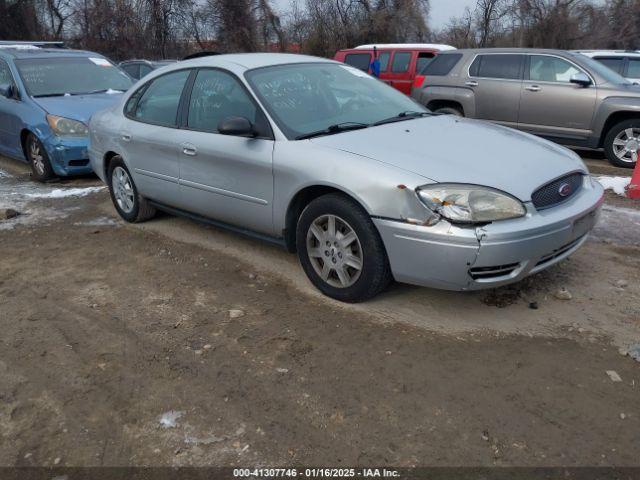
[334,43,455,95]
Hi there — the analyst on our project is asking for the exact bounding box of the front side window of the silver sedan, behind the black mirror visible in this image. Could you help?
[187,69,264,133]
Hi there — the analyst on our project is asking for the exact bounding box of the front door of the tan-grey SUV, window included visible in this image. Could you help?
[518,55,597,142]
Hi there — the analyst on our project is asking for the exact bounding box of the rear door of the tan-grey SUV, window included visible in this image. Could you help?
[465,53,524,128]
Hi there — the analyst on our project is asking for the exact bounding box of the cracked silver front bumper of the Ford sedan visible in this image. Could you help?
[373,182,603,290]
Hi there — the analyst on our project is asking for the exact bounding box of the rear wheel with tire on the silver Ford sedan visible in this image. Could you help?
[107,155,156,223]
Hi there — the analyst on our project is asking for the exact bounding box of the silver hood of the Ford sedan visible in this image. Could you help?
[312,115,586,201]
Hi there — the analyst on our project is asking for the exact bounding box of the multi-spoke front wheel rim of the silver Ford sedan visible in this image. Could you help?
[306,214,364,288]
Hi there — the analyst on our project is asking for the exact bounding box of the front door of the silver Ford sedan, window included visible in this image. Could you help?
[180,68,274,234]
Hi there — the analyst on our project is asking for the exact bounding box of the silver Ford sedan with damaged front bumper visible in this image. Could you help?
[89,54,603,302]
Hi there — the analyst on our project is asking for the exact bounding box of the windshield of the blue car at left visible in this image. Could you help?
[16,57,131,97]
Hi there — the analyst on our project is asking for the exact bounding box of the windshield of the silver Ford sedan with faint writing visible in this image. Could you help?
[246,63,428,139]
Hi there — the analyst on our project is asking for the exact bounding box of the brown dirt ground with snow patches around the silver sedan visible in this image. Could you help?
[0,158,640,467]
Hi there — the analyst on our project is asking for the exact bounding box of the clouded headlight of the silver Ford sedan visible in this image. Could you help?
[416,183,526,223]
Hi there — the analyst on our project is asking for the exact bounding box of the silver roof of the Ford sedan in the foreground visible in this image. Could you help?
[176,53,338,70]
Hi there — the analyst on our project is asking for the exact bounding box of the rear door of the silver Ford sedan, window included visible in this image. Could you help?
[120,70,191,205]
